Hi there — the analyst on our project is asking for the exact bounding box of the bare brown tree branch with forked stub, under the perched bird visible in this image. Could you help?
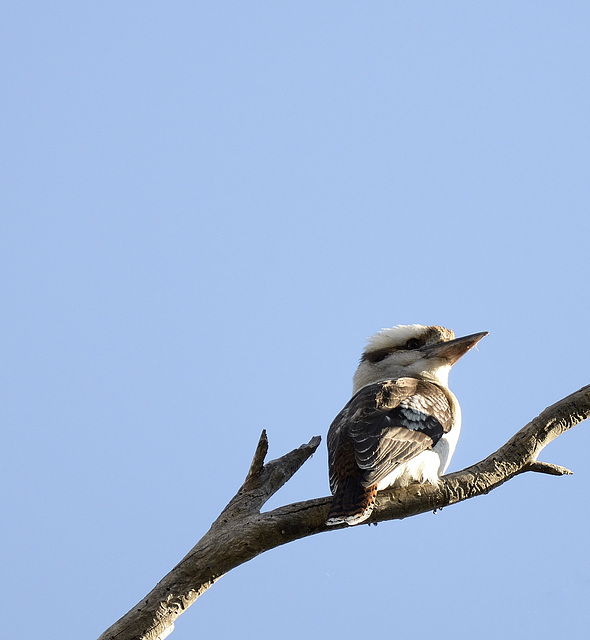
[99,385,590,640]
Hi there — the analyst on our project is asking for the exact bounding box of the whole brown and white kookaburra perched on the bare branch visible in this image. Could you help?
[326,324,487,525]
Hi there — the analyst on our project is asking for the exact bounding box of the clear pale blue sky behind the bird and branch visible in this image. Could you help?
[0,5,590,640]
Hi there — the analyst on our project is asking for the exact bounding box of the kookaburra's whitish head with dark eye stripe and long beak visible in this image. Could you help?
[353,324,488,393]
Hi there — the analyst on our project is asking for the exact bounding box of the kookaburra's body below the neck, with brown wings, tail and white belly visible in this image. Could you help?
[327,377,460,524]
